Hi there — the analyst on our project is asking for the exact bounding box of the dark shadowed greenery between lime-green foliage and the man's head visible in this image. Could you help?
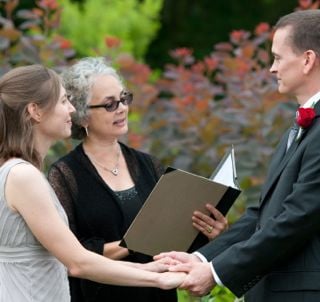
[146,0,300,68]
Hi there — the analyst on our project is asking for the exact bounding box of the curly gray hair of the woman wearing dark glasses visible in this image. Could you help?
[61,57,124,139]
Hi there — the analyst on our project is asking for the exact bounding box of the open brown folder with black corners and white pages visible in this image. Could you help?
[120,147,241,256]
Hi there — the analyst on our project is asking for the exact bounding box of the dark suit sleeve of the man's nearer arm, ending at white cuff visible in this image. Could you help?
[208,125,320,296]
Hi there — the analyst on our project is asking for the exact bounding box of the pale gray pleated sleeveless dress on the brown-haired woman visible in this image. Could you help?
[0,159,70,302]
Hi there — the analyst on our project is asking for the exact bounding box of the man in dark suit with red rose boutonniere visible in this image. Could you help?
[155,10,320,302]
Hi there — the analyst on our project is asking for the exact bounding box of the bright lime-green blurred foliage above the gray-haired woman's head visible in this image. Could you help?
[60,0,163,58]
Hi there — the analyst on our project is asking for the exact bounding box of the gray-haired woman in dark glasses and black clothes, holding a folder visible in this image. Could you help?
[48,57,227,302]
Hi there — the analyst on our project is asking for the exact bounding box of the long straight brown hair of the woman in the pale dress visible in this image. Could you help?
[0,65,61,168]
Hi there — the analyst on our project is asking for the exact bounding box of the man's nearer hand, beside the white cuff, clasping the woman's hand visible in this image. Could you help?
[169,262,216,296]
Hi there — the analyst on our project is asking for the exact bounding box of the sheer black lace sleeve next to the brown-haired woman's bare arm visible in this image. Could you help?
[48,162,76,234]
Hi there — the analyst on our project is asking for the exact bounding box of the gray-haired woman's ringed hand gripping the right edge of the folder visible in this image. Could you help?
[192,204,228,240]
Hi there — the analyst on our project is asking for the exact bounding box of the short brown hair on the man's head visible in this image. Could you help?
[275,9,320,55]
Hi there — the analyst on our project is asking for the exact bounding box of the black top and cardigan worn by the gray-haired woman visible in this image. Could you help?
[48,144,206,302]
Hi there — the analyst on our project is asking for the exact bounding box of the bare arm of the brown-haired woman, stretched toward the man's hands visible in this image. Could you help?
[5,164,185,289]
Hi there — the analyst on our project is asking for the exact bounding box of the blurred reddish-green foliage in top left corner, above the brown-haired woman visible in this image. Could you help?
[0,0,74,75]
